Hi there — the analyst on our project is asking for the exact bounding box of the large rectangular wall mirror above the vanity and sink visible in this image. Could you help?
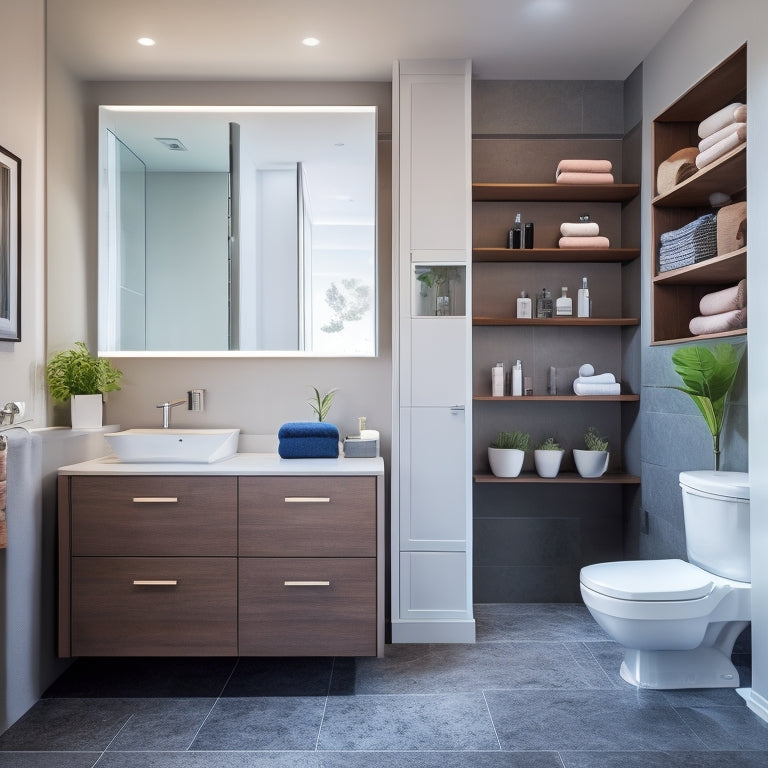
[99,106,377,357]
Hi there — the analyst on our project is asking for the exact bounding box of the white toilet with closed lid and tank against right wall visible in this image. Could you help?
[580,471,752,689]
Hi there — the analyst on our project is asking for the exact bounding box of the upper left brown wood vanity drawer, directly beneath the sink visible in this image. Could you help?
[71,476,237,557]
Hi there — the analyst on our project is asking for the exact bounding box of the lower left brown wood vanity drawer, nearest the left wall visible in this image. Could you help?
[72,557,237,656]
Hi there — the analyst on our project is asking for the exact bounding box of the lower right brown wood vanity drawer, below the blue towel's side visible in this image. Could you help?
[239,558,376,656]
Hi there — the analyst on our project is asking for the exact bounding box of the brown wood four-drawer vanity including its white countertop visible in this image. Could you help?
[59,453,385,657]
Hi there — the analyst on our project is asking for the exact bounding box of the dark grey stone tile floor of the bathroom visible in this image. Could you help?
[0,604,768,768]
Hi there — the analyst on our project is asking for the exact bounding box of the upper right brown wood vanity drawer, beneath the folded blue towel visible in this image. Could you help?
[240,477,376,557]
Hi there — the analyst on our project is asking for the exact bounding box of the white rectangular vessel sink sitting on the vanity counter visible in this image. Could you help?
[104,428,240,464]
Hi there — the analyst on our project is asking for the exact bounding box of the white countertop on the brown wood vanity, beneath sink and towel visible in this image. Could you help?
[59,453,384,475]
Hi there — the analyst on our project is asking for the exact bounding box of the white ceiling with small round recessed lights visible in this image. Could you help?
[47,0,691,81]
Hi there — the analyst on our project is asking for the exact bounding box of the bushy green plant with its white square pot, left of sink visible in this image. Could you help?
[45,341,123,429]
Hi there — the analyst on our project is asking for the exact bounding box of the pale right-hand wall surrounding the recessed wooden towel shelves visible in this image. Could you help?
[642,0,768,720]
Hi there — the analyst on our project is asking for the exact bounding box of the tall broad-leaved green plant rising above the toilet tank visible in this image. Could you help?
[672,342,745,470]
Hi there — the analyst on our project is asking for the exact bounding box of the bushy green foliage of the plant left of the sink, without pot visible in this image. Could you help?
[45,341,123,402]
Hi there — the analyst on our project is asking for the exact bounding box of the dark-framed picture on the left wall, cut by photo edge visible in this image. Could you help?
[0,147,21,341]
